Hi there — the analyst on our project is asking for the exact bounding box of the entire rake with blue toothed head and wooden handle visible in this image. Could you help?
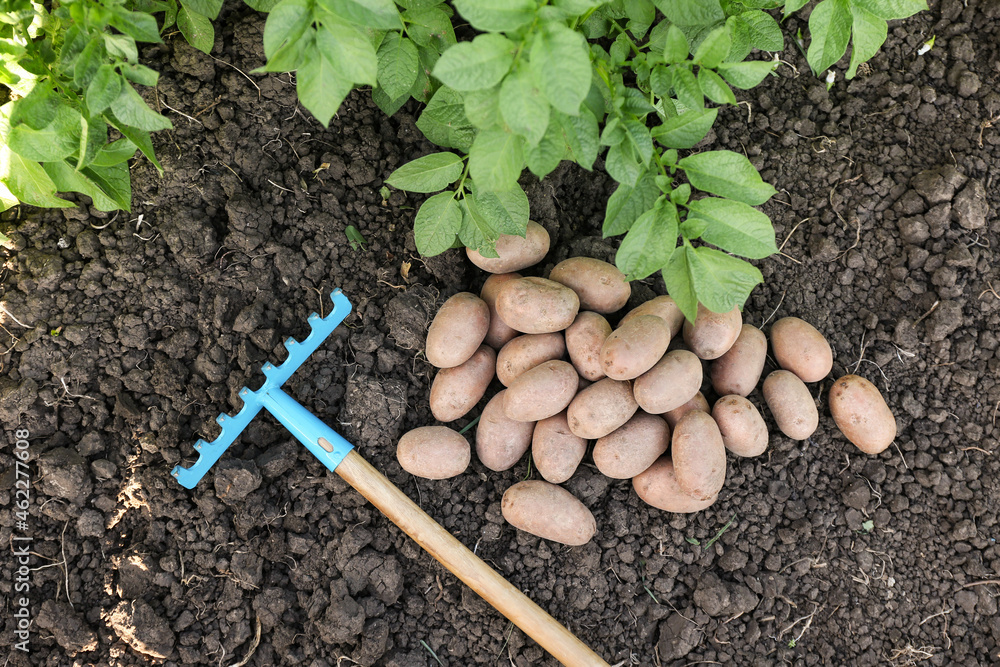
[171,289,608,667]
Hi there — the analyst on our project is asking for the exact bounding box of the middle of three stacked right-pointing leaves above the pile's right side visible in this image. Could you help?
[687,197,778,259]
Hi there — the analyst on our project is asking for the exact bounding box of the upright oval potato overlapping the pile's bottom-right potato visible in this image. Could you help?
[670,410,726,500]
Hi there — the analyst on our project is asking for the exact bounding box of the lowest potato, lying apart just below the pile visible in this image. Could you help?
[500,480,597,547]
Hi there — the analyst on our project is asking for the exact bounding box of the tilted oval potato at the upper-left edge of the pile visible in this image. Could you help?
[425,292,490,368]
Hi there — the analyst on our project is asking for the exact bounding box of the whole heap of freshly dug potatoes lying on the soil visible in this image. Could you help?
[397,222,896,545]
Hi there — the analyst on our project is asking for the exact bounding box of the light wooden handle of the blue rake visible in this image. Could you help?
[336,449,608,667]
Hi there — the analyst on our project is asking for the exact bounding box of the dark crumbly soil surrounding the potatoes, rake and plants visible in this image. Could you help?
[0,0,1000,667]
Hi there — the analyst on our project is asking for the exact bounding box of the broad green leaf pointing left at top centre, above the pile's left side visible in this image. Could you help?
[434,34,517,90]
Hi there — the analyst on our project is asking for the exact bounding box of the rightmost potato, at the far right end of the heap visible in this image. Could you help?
[830,375,896,454]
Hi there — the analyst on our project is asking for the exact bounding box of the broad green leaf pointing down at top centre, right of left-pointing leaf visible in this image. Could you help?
[531,23,593,116]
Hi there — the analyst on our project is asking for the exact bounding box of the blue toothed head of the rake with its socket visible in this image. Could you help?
[170,289,351,489]
